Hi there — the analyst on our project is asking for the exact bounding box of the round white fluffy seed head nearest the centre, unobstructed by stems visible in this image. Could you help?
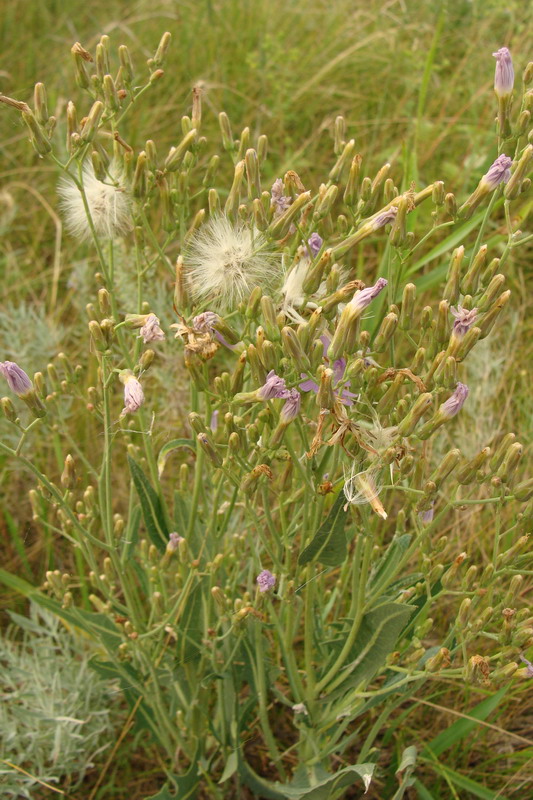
[184,214,280,309]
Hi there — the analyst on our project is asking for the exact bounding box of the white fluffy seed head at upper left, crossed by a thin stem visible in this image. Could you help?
[58,161,132,239]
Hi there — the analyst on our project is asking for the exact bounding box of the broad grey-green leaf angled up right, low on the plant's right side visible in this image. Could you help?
[325,603,413,702]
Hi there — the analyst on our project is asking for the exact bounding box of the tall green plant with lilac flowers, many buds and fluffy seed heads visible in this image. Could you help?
[0,34,533,800]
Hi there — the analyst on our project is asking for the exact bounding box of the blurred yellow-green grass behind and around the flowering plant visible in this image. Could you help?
[0,0,533,800]
